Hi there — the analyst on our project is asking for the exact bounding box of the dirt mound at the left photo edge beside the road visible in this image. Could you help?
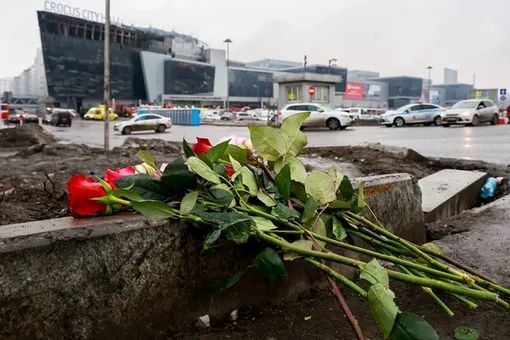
[0,124,58,148]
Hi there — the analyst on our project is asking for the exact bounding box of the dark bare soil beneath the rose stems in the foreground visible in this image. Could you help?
[169,281,510,340]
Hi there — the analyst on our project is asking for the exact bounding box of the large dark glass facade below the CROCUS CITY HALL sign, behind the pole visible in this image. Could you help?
[41,32,146,100]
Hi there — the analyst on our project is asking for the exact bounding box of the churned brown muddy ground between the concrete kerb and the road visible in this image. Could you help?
[0,125,510,226]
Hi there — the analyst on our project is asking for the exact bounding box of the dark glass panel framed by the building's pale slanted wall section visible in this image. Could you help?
[165,60,216,95]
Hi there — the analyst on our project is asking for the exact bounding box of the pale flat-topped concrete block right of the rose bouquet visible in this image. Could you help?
[418,169,488,223]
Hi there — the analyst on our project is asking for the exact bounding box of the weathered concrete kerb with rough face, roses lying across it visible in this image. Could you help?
[0,174,425,339]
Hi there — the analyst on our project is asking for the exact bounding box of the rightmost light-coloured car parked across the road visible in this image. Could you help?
[441,99,499,127]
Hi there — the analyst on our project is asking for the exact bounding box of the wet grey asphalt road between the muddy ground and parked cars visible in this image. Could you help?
[43,120,510,164]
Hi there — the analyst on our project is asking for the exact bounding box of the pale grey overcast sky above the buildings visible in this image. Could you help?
[0,0,510,88]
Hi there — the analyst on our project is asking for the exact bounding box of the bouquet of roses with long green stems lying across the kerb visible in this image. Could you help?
[67,113,510,340]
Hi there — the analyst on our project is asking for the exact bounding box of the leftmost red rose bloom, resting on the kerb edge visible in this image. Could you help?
[67,175,107,217]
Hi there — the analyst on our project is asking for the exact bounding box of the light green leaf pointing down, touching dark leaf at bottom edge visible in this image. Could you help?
[368,283,399,338]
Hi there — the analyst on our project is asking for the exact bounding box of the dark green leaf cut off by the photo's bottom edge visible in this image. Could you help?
[390,312,440,340]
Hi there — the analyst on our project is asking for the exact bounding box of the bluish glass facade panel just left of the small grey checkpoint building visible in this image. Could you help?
[228,69,273,98]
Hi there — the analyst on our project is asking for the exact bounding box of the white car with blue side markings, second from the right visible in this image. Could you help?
[379,103,446,127]
